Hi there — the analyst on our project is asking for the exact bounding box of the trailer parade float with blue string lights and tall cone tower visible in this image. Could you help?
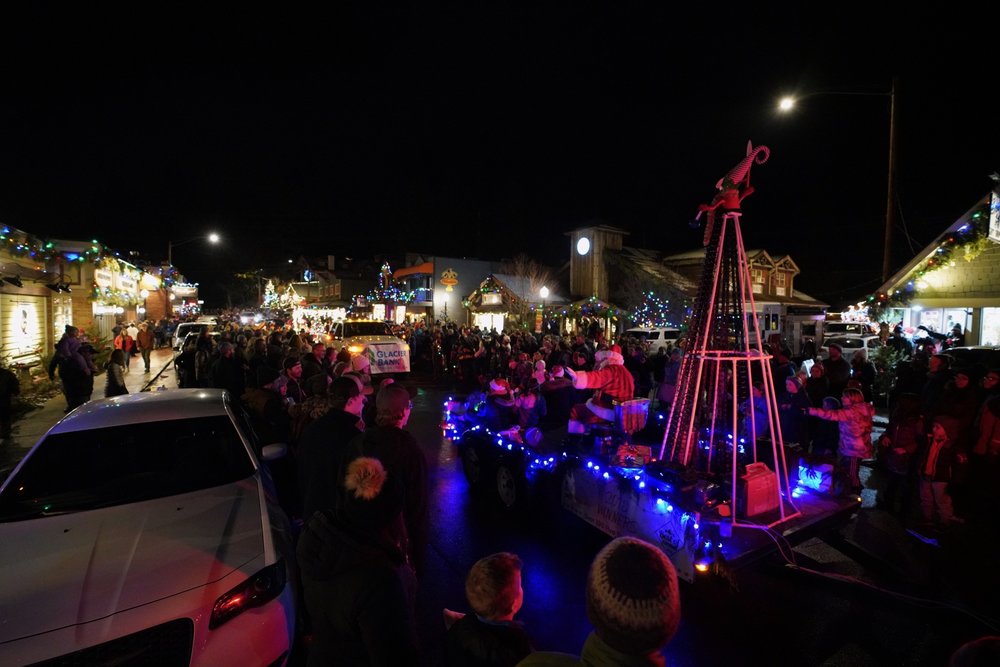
[442,145,860,581]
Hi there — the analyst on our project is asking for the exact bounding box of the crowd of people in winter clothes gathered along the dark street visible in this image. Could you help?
[33,320,1000,665]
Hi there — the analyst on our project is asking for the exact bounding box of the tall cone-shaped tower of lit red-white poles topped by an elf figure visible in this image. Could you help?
[660,143,798,525]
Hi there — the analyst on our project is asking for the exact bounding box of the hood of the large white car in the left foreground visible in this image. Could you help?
[0,477,264,643]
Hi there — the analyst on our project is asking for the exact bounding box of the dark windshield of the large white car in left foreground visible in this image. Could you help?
[0,415,254,522]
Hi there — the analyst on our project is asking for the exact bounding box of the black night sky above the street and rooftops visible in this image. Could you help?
[0,2,1000,305]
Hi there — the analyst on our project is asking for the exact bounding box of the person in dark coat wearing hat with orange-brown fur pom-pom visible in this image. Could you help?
[297,457,419,667]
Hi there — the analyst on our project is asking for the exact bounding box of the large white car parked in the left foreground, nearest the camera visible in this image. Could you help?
[0,389,296,667]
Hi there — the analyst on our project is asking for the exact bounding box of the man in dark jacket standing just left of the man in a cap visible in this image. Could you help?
[298,377,365,521]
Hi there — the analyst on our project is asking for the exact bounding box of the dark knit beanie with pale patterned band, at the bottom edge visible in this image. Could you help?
[587,537,681,655]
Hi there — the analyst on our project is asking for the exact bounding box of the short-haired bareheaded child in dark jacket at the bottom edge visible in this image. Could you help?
[445,552,533,667]
